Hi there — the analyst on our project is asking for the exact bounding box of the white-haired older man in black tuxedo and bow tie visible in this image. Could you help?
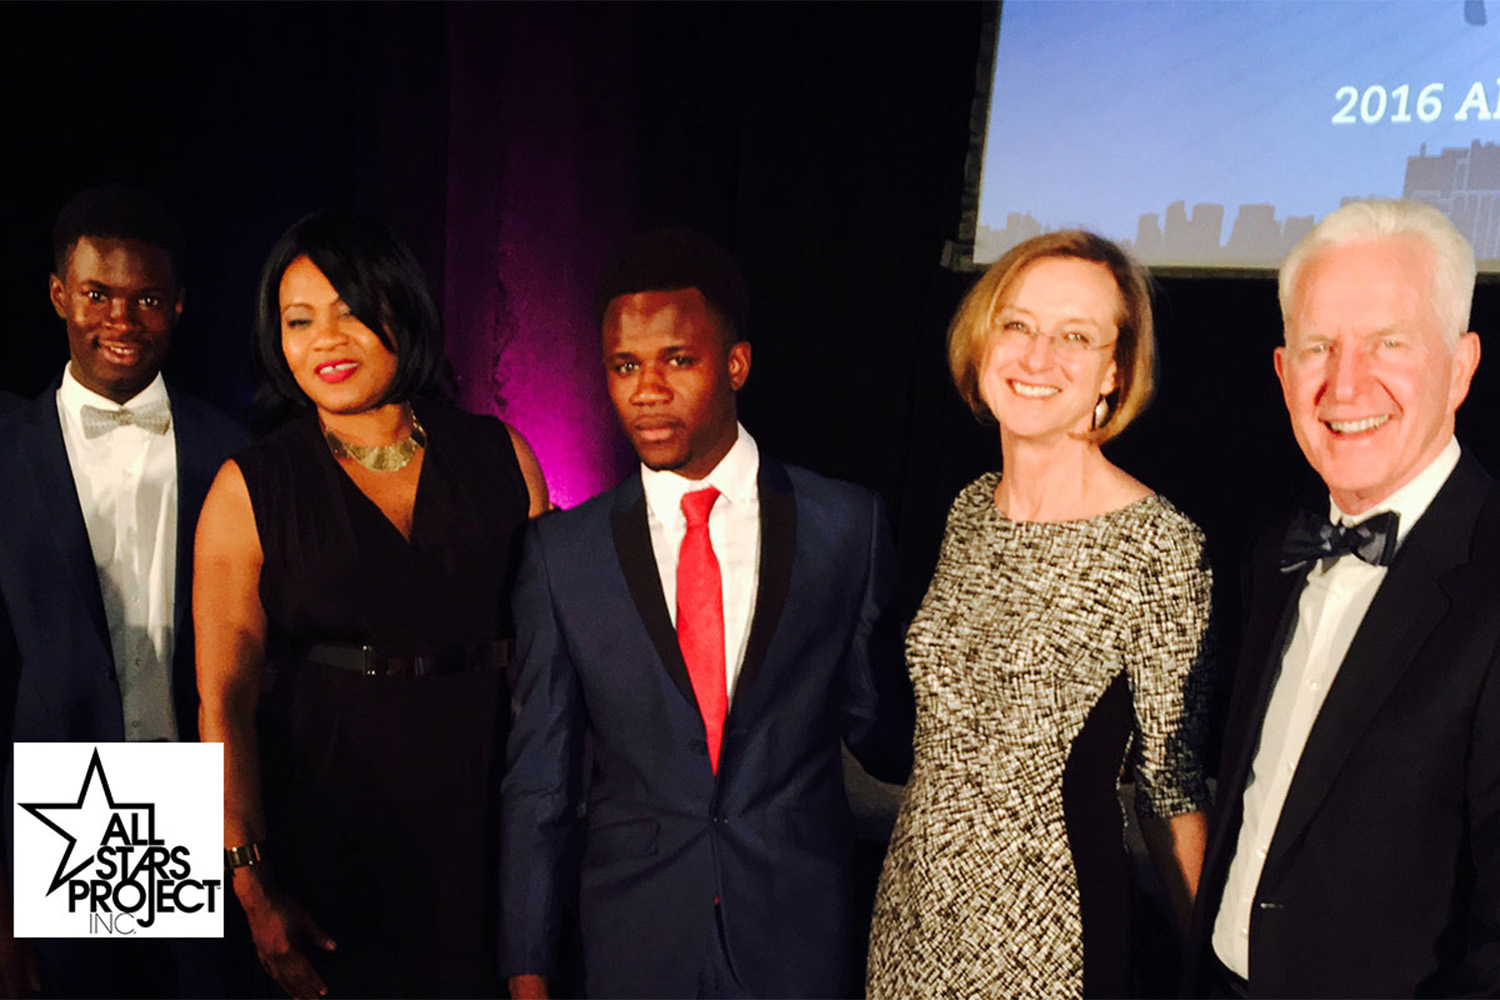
[1188,201,1500,997]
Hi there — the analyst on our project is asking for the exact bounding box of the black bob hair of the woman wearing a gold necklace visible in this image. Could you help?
[255,211,453,417]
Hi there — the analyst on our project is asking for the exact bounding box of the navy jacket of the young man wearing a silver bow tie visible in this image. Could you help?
[0,381,249,851]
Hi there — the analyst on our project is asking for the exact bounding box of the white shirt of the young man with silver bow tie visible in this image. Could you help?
[57,364,177,741]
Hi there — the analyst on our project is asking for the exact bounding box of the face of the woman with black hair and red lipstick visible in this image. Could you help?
[281,256,396,414]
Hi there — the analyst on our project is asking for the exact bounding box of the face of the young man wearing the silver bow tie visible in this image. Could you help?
[48,235,183,403]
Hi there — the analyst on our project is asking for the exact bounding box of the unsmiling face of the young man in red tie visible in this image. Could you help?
[605,288,750,480]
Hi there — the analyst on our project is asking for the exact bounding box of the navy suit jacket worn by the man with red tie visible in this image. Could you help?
[501,456,912,997]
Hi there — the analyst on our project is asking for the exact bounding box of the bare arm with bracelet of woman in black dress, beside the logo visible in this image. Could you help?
[192,462,333,997]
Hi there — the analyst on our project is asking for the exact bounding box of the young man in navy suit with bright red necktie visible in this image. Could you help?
[501,231,912,997]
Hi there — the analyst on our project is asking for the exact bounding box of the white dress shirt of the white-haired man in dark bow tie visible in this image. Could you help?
[1214,438,1460,979]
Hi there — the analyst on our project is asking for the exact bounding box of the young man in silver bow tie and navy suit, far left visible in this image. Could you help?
[0,187,248,996]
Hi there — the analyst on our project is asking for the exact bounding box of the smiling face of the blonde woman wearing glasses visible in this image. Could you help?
[980,256,1121,439]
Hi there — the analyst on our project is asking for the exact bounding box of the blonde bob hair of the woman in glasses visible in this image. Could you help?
[948,229,1157,444]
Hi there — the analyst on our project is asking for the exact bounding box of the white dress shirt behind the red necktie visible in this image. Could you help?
[641,426,761,702]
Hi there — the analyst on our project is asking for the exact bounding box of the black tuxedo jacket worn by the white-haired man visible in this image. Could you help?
[1188,454,1500,997]
